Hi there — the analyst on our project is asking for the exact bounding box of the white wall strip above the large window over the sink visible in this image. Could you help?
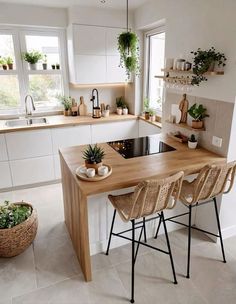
[0,3,67,28]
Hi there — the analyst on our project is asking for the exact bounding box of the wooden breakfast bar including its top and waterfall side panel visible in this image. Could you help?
[60,135,226,281]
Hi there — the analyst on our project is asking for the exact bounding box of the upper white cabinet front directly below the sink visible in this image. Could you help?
[6,129,52,160]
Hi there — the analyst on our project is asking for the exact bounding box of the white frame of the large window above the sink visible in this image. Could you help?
[0,26,69,117]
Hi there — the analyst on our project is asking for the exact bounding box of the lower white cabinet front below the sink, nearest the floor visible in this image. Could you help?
[10,155,55,186]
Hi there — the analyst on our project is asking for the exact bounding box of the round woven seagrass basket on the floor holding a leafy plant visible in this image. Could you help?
[0,202,38,258]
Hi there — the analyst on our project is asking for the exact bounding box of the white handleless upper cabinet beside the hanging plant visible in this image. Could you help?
[67,24,127,84]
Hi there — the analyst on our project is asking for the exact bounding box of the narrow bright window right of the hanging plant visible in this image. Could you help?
[144,29,165,114]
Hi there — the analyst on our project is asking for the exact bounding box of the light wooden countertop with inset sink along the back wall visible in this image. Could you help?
[0,114,138,133]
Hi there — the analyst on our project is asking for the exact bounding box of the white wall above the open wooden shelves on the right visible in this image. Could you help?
[135,0,236,102]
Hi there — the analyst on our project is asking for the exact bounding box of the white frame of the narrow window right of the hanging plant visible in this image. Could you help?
[143,25,166,114]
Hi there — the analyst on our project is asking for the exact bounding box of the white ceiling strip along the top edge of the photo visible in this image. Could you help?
[0,0,150,10]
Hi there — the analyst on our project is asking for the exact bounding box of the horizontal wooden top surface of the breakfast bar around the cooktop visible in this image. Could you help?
[60,134,226,196]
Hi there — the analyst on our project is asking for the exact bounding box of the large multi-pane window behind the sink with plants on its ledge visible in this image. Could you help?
[0,28,67,114]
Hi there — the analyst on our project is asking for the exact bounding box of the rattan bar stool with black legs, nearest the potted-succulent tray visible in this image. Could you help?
[106,172,184,303]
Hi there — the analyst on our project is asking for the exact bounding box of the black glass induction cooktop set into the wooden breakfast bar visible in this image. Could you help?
[108,135,176,158]
